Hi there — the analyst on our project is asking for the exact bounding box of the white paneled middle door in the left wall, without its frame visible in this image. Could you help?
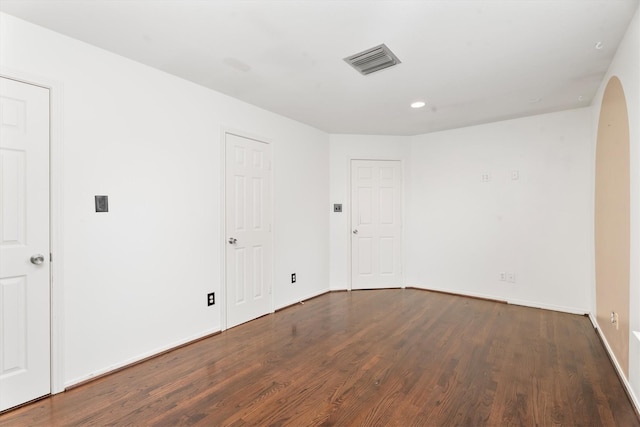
[225,134,272,328]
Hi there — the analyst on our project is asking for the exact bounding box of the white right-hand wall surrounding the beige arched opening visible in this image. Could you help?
[591,2,640,405]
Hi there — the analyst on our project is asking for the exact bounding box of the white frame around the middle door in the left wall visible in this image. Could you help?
[220,127,276,331]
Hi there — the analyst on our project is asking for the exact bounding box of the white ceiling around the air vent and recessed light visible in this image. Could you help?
[0,0,638,135]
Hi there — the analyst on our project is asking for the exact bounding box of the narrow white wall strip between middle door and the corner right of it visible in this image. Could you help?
[272,125,329,309]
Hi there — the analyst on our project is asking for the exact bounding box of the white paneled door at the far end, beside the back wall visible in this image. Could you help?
[351,160,402,289]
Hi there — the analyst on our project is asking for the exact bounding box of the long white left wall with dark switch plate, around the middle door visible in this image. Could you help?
[0,14,329,385]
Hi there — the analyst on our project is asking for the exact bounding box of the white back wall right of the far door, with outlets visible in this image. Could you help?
[405,108,593,313]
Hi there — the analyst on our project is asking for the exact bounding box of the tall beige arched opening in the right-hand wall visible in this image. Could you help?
[594,77,630,377]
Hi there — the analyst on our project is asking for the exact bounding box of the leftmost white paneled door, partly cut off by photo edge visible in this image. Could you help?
[0,78,51,410]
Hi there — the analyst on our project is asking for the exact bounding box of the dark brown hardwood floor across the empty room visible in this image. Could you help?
[0,289,640,427]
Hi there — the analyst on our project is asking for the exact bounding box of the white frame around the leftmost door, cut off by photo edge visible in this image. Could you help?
[0,70,65,394]
